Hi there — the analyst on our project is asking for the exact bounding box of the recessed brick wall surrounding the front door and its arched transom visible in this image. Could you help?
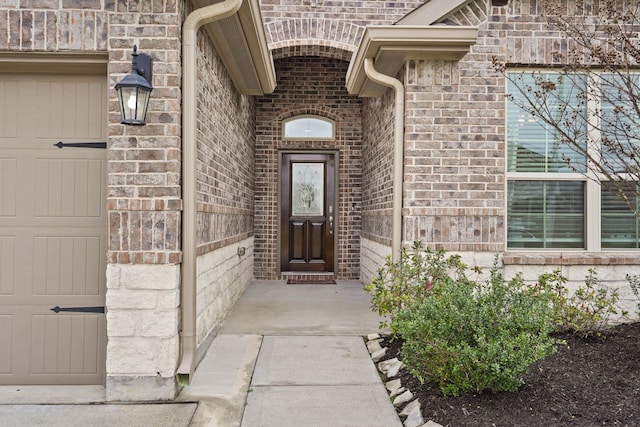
[254,57,362,279]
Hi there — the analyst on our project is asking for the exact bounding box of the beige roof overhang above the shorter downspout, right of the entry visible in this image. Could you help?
[346,25,478,97]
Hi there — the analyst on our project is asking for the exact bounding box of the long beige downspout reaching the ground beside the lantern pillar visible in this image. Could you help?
[176,0,243,385]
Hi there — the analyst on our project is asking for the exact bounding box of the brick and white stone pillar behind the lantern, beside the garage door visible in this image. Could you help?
[107,0,185,400]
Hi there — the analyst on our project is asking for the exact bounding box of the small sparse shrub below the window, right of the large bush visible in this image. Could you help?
[538,269,628,338]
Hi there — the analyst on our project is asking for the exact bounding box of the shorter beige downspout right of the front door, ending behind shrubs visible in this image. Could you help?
[364,58,405,262]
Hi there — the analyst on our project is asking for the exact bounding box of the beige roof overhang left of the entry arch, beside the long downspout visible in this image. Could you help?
[194,0,276,95]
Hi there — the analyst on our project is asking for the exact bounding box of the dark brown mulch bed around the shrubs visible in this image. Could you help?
[385,322,640,427]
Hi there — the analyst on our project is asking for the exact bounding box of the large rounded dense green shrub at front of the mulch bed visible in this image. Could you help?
[392,265,556,396]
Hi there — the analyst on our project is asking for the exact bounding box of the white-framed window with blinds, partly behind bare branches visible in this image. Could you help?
[506,72,640,251]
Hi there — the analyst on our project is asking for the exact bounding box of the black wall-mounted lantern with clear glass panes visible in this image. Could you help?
[116,45,153,126]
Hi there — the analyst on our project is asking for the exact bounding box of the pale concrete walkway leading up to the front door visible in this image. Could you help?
[180,281,402,427]
